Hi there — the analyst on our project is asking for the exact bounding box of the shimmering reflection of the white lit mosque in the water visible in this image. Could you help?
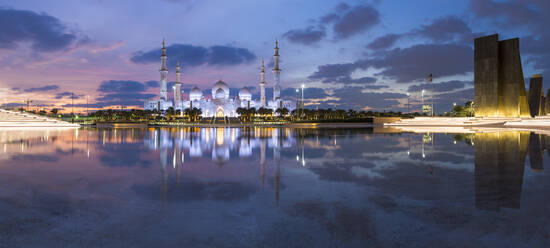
[144,127,295,207]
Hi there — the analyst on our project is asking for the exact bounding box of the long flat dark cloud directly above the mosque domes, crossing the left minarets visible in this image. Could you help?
[130,44,256,67]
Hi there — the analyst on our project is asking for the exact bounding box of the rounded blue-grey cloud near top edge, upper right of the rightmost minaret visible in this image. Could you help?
[333,5,380,39]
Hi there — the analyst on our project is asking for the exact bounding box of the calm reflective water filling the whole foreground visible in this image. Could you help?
[0,128,550,247]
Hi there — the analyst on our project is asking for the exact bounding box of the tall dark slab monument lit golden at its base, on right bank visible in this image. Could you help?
[474,34,530,117]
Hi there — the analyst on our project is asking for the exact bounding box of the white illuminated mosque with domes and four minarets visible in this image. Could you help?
[144,41,295,117]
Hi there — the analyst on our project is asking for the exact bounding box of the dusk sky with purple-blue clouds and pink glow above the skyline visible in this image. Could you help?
[0,0,550,113]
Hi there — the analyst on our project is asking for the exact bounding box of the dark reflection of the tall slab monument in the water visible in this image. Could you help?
[475,132,529,211]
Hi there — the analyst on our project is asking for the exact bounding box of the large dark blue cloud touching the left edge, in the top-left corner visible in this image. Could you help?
[0,8,85,52]
